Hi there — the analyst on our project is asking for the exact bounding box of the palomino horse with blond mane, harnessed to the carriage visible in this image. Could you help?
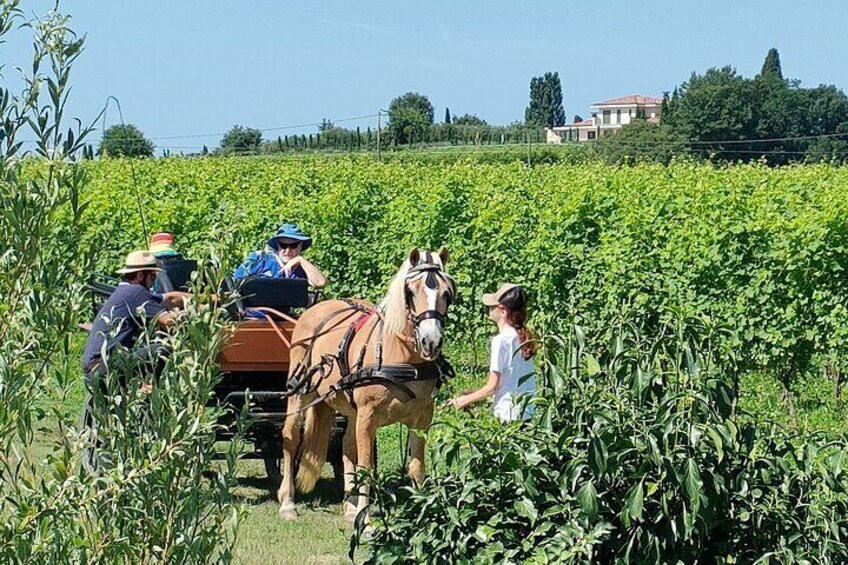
[277,248,456,519]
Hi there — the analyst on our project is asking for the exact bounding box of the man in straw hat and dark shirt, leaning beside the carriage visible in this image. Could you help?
[82,251,187,384]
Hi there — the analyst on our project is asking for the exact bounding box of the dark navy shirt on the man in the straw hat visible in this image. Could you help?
[82,283,164,371]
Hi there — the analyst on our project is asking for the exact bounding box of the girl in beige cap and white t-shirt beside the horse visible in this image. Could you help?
[448,283,536,422]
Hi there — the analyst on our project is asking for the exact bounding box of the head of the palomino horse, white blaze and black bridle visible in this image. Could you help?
[404,247,456,360]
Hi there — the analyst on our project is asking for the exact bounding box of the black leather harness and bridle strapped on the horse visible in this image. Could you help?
[286,263,455,410]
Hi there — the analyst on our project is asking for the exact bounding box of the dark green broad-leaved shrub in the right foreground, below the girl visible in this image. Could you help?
[352,313,848,564]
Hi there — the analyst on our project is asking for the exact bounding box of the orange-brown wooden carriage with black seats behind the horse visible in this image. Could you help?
[84,259,346,491]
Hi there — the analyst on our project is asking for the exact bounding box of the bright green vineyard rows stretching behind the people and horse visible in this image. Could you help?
[76,158,848,381]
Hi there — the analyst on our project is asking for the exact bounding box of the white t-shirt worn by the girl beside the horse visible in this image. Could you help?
[489,326,536,422]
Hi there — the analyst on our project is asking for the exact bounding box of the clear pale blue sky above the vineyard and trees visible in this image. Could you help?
[3,0,848,152]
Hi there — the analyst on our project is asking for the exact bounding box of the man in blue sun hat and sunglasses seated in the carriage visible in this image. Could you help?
[233,224,327,288]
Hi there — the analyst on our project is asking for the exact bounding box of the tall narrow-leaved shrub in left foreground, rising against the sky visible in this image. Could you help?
[0,1,243,564]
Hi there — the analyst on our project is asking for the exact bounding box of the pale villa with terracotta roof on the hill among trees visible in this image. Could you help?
[545,94,668,143]
